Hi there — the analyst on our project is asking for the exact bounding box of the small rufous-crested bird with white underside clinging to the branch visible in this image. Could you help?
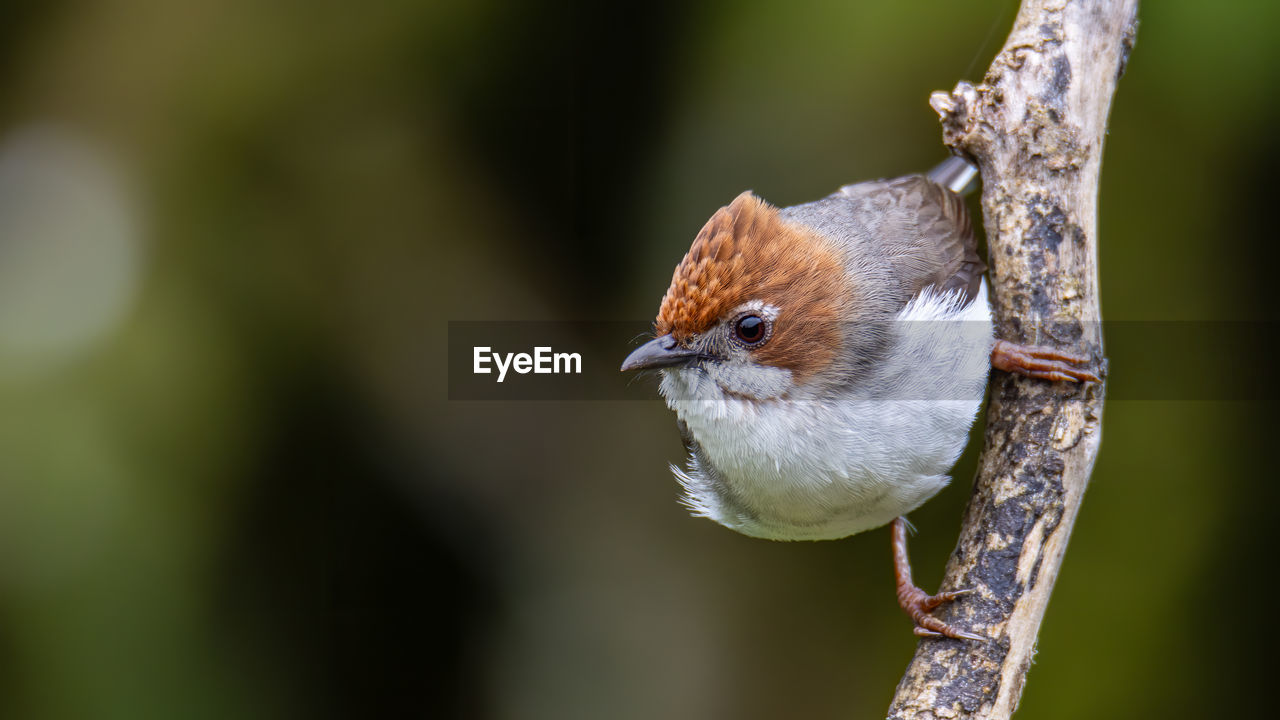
[622,158,1098,639]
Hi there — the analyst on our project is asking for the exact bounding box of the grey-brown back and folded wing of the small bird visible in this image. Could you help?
[783,176,987,307]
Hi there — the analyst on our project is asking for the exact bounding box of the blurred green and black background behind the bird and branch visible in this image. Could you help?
[0,0,1280,720]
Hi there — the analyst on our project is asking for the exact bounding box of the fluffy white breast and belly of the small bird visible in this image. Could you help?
[660,283,992,539]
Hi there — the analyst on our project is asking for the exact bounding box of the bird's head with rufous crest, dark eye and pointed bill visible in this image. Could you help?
[622,192,859,400]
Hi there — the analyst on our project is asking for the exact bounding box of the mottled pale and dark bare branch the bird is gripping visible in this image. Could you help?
[888,0,1138,720]
